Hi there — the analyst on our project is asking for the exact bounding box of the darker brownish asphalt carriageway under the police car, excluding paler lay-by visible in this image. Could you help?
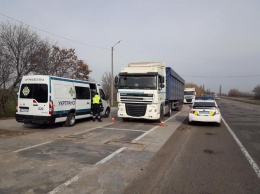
[124,100,260,194]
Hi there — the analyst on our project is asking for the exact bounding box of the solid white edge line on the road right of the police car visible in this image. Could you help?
[222,117,260,178]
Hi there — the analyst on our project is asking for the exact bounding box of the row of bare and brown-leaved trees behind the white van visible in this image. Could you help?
[0,23,91,115]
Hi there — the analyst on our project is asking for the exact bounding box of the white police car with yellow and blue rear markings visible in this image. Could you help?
[188,100,221,126]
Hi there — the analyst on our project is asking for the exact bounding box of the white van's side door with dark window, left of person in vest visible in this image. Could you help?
[74,81,91,118]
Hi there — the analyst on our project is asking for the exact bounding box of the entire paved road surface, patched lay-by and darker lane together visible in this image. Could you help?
[0,99,260,194]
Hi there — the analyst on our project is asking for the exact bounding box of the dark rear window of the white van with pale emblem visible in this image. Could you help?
[20,84,48,103]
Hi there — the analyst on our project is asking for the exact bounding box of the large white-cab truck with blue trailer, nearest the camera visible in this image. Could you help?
[115,62,185,122]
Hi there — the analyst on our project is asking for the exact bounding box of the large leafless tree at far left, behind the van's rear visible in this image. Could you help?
[0,23,45,114]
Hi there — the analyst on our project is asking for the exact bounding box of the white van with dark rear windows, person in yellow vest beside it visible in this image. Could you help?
[15,75,110,127]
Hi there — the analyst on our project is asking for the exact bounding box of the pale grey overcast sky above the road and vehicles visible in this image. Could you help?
[0,0,260,93]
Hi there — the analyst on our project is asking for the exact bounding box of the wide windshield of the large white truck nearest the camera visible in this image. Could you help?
[118,75,157,90]
